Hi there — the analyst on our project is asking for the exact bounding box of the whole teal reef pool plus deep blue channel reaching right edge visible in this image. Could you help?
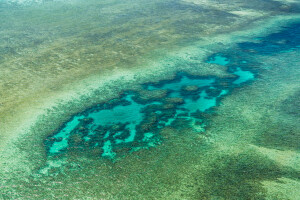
[45,21,300,164]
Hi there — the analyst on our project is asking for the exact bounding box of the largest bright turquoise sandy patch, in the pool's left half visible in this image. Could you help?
[49,95,156,158]
